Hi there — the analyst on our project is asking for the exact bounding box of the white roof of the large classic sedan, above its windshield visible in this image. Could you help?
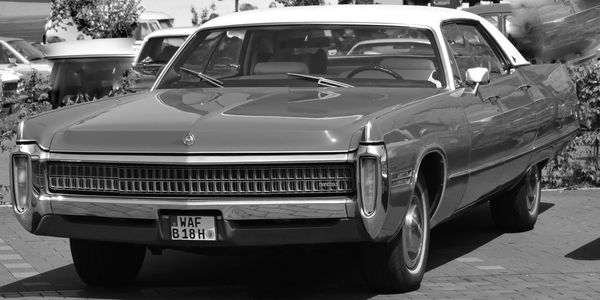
[201,5,480,28]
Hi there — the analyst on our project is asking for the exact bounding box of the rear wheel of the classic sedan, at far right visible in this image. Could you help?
[490,165,541,232]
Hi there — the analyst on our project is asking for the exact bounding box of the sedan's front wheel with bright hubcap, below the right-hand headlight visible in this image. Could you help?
[363,177,429,293]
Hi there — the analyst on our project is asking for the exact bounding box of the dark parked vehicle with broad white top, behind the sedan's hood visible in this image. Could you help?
[46,38,134,108]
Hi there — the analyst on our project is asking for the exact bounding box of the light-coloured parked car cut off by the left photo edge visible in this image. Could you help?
[0,37,52,76]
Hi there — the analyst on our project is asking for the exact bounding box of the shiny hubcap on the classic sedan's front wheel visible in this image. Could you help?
[402,195,425,270]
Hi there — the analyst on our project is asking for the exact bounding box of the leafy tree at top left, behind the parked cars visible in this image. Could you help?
[49,0,144,39]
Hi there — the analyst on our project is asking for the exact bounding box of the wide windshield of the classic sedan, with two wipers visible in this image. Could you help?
[157,25,446,89]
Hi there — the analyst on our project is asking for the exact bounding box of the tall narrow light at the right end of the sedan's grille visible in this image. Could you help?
[360,156,380,217]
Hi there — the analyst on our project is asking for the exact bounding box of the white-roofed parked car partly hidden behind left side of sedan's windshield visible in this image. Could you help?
[133,27,197,89]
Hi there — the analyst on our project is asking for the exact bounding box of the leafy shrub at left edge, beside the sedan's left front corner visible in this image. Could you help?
[0,72,52,152]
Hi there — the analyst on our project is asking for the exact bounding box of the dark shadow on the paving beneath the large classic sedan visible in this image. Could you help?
[0,203,553,299]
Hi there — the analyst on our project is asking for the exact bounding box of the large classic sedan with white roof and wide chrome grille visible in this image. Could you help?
[11,5,579,292]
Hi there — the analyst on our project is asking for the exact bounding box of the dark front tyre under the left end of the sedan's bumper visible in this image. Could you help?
[70,239,146,285]
